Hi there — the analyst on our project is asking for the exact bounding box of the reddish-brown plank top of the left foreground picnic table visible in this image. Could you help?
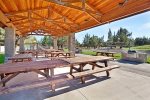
[0,59,69,74]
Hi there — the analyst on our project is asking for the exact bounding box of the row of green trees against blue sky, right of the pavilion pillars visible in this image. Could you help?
[76,28,150,48]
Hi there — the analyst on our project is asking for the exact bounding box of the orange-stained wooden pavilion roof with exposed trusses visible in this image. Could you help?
[0,0,150,36]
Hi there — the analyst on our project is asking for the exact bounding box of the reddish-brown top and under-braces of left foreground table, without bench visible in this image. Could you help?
[0,59,69,86]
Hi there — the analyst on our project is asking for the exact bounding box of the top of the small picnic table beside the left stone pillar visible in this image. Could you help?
[8,54,33,60]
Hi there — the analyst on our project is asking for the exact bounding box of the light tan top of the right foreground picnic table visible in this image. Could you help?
[62,56,113,64]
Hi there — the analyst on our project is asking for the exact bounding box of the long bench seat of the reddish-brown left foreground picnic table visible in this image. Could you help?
[0,75,70,94]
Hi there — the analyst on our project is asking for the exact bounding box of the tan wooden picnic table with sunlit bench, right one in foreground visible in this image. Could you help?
[64,56,118,83]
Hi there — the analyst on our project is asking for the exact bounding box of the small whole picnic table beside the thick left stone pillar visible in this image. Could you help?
[8,54,33,63]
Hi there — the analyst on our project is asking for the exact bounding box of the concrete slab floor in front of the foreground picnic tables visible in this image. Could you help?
[0,68,150,100]
